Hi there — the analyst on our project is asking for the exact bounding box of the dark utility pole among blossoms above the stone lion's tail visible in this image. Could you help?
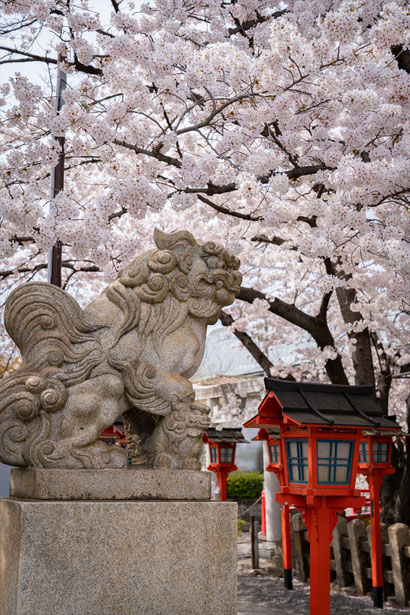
[48,53,67,287]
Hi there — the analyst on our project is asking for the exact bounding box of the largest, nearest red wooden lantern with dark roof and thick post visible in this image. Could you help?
[245,378,400,615]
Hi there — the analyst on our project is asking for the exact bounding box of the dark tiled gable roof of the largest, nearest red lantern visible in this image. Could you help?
[253,378,400,431]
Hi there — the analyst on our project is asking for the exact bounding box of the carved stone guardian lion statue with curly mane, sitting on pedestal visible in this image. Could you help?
[0,229,241,470]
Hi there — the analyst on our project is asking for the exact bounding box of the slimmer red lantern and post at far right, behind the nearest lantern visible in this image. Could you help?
[358,430,396,609]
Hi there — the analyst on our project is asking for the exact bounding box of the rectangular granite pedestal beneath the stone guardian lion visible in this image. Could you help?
[0,470,237,615]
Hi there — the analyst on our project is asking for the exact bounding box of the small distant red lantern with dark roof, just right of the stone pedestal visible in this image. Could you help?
[203,427,248,502]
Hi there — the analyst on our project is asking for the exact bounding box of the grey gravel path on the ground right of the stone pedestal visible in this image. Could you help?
[238,534,410,615]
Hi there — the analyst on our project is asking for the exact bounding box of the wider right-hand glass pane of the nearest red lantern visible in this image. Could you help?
[317,440,354,485]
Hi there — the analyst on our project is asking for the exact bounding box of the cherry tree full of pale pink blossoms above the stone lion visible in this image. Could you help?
[0,0,410,516]
